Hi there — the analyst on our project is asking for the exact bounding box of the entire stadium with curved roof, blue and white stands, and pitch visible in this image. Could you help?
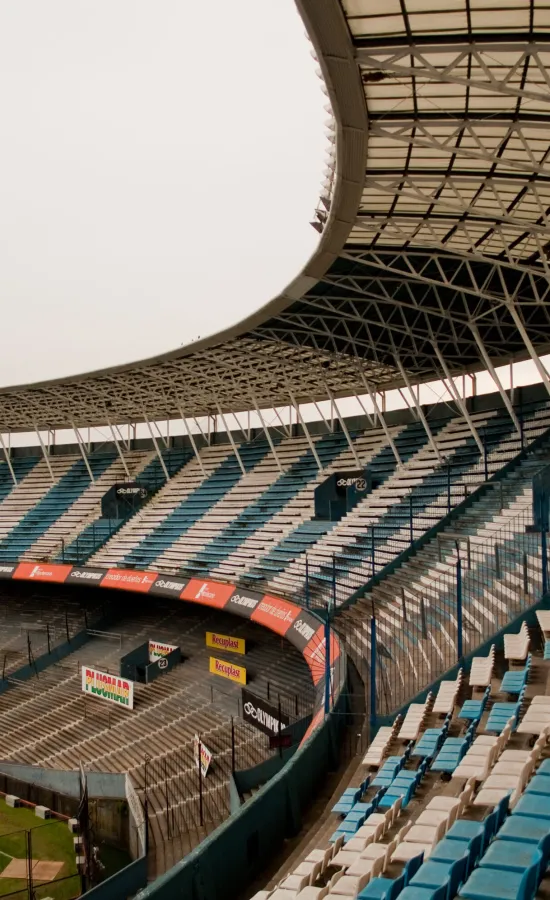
[0,0,550,900]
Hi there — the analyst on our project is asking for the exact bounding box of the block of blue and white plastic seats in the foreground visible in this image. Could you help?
[254,620,550,900]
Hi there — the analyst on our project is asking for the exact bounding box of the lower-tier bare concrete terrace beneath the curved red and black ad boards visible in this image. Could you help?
[0,590,315,874]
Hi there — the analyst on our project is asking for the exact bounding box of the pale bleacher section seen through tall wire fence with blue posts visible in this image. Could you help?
[335,492,548,715]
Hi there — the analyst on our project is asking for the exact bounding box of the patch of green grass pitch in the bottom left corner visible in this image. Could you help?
[0,798,80,900]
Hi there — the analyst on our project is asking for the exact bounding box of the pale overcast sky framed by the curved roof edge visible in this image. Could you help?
[0,0,327,385]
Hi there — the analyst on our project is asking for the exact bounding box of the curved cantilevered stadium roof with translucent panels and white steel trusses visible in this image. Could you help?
[0,0,550,430]
